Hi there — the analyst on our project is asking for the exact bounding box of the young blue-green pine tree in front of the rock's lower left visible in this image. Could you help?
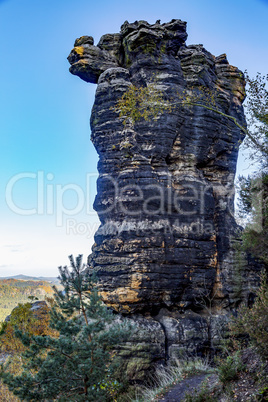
[1,255,129,401]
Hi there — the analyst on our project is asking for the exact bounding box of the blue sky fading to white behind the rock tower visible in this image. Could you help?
[0,0,268,276]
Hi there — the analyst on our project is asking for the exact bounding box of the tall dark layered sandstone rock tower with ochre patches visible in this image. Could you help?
[68,20,262,376]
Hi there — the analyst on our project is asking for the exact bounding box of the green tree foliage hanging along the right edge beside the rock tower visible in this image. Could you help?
[239,73,268,264]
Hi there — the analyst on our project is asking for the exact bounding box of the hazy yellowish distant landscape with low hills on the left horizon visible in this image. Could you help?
[0,275,56,322]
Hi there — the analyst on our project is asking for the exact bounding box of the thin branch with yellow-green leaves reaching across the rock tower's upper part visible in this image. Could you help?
[111,75,268,153]
